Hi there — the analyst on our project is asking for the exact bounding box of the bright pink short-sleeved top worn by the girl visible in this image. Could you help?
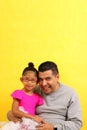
[11,90,43,115]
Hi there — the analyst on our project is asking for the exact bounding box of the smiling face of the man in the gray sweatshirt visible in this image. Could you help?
[39,70,59,94]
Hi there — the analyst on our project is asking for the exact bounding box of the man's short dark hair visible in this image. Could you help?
[38,61,59,74]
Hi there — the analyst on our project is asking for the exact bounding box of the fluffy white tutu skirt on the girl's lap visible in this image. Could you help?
[1,117,38,130]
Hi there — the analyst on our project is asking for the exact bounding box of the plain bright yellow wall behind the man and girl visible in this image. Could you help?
[0,0,87,130]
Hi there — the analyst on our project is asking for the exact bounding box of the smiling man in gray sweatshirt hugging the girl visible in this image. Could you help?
[8,61,82,130]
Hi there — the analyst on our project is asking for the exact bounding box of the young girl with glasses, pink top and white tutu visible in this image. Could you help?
[2,62,44,130]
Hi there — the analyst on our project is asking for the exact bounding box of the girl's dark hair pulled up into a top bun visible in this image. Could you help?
[22,62,38,77]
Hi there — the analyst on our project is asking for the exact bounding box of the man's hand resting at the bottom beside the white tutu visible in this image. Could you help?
[36,122,54,130]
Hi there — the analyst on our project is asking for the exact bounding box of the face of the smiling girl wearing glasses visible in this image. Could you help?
[20,71,37,92]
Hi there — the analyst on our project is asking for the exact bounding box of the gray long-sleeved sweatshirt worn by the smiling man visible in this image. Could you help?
[36,83,82,130]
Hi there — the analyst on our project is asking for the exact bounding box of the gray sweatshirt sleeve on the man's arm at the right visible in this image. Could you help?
[56,93,82,130]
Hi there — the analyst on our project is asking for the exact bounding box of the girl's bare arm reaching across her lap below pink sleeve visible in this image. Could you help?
[12,99,44,122]
